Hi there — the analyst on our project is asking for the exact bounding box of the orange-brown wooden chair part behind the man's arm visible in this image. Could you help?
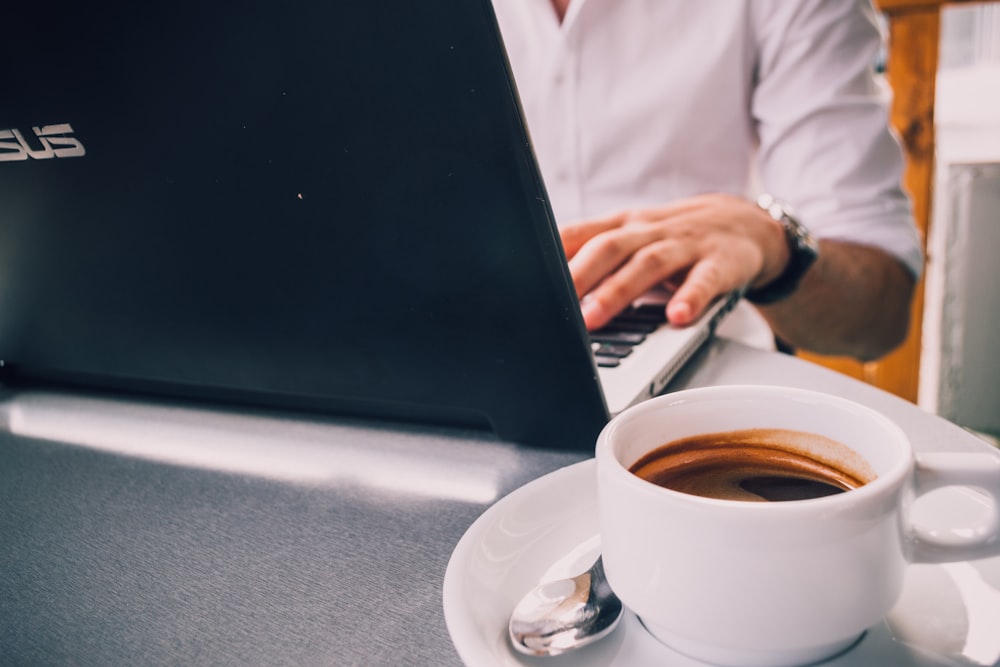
[800,0,976,402]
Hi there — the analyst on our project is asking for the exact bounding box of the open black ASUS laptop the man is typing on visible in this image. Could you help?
[0,0,733,451]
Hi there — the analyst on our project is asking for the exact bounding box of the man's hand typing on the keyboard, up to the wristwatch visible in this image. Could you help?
[561,194,788,330]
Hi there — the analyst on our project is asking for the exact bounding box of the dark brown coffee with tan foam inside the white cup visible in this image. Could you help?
[629,429,875,501]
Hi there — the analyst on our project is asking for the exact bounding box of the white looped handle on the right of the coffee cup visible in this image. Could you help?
[909,452,1000,563]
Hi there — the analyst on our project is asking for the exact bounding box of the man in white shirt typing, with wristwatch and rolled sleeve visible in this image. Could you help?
[494,0,922,360]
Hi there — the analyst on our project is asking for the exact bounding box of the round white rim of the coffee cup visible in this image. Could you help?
[595,384,914,514]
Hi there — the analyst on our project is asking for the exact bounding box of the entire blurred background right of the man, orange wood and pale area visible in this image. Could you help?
[799,0,1000,444]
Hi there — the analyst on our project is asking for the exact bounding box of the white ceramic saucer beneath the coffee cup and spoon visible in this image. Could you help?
[444,460,1000,667]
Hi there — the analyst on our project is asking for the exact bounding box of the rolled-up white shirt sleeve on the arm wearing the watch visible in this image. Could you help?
[751,0,923,276]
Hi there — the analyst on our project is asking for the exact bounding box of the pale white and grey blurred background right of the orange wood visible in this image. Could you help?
[919,2,1000,438]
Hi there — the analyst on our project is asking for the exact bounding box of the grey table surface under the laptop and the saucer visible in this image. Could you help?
[0,339,985,666]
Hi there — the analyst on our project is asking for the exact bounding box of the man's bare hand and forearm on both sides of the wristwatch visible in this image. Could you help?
[562,194,915,360]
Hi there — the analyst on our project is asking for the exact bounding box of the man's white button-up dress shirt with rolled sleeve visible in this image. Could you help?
[494,0,922,274]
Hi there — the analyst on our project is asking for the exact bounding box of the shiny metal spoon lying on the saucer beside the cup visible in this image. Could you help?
[507,558,623,655]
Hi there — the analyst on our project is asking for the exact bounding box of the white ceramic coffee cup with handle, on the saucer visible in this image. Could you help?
[596,386,1000,667]
